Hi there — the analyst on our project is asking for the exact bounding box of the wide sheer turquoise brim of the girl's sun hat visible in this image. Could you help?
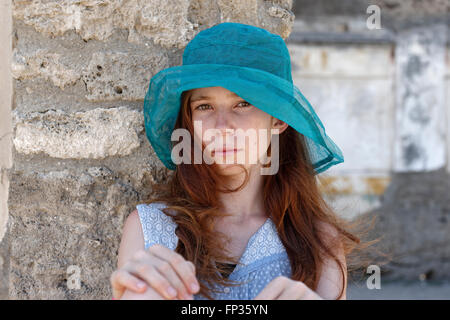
[144,64,344,174]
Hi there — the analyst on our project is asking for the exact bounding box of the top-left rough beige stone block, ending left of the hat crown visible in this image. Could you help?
[13,0,194,47]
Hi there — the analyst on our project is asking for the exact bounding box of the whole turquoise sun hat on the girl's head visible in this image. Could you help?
[144,22,344,174]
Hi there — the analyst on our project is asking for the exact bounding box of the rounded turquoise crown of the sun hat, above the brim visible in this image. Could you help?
[183,22,292,83]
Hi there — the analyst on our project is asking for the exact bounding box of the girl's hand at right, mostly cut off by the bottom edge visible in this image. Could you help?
[254,276,323,300]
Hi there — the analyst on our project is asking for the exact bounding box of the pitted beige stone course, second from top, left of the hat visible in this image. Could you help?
[12,33,169,101]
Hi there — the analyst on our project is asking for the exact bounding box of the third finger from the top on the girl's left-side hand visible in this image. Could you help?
[128,262,177,300]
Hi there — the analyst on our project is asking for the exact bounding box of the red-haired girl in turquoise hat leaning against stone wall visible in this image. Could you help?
[111,22,368,300]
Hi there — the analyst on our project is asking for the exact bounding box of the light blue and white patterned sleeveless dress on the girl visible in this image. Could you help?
[136,202,291,300]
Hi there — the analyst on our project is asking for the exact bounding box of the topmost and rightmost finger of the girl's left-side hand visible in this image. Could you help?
[149,245,200,294]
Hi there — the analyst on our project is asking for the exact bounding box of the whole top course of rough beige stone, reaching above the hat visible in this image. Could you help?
[13,0,294,48]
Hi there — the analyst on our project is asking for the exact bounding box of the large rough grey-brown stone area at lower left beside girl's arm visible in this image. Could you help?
[9,166,167,299]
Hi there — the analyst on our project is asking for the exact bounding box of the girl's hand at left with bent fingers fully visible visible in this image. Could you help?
[110,244,200,300]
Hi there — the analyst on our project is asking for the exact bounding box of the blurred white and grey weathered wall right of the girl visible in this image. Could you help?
[288,0,450,281]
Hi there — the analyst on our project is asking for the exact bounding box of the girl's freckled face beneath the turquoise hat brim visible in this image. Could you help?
[189,87,287,174]
